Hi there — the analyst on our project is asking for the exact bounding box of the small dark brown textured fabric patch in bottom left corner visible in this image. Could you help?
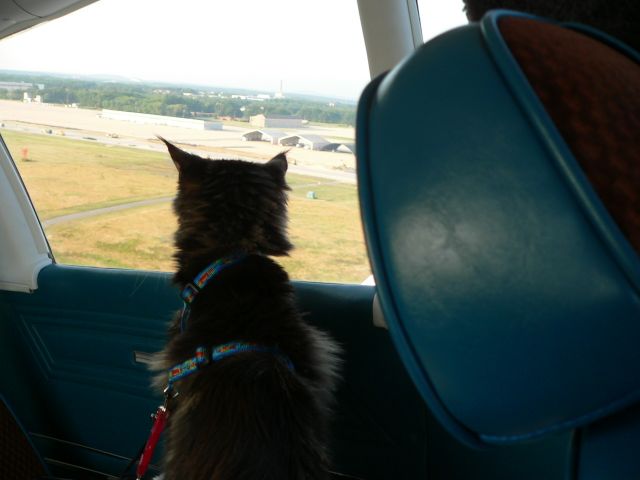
[0,400,46,480]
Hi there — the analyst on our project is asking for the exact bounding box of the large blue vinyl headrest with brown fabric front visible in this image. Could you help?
[356,11,640,444]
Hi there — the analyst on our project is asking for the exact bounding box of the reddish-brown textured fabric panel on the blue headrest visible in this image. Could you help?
[499,17,640,252]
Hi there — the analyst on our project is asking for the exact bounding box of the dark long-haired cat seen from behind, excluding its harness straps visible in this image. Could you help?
[155,140,338,480]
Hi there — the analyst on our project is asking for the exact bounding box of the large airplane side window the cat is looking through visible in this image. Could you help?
[0,0,370,283]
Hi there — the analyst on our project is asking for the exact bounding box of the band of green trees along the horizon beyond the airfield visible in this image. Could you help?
[0,74,355,125]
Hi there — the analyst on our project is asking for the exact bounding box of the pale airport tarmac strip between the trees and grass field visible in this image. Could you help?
[0,100,356,184]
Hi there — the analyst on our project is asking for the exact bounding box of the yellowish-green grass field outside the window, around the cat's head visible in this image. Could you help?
[2,130,370,283]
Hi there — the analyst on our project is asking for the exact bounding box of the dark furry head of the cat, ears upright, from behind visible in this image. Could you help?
[161,138,292,267]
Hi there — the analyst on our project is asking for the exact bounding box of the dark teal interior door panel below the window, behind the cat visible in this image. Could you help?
[0,265,427,479]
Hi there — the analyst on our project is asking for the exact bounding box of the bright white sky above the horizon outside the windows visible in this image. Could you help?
[0,0,466,100]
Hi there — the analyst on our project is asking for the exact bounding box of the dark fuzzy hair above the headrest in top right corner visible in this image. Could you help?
[463,0,640,50]
